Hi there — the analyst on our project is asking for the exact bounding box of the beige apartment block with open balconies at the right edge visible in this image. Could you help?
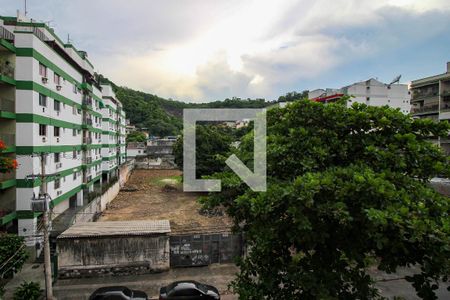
[411,62,450,154]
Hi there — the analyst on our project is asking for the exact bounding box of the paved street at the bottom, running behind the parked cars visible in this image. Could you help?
[5,264,450,300]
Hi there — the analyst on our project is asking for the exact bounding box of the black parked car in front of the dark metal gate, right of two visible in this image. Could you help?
[159,281,220,300]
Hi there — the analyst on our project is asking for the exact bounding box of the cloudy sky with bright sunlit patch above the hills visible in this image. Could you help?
[0,0,450,102]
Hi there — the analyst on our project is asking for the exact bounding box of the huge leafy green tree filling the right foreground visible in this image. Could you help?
[203,100,450,300]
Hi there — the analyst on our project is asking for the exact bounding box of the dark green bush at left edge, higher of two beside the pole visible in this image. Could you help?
[0,233,28,277]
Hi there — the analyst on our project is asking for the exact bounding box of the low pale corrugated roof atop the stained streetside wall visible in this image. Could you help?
[58,220,171,239]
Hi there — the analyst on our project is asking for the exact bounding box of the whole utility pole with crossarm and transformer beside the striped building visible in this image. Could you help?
[27,153,53,300]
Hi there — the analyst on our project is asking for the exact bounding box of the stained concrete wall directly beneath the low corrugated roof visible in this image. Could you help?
[57,234,170,278]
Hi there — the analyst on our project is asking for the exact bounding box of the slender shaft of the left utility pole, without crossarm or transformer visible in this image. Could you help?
[39,153,53,300]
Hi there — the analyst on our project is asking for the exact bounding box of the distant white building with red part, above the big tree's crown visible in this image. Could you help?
[308,78,411,114]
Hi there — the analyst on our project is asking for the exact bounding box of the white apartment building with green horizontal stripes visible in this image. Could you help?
[0,16,126,253]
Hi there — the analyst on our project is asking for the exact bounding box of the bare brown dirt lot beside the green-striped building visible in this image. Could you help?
[99,170,231,233]
